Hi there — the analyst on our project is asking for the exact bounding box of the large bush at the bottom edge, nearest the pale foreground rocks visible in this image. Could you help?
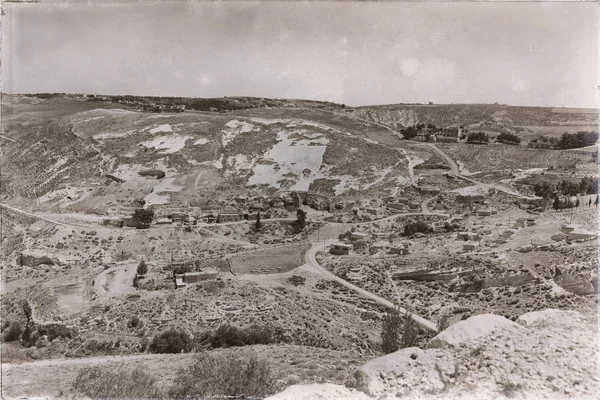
[169,353,276,399]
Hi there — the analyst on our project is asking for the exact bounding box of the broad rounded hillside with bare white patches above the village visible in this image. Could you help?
[1,96,408,212]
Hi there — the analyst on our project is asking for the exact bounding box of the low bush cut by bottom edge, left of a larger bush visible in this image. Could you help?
[73,366,163,399]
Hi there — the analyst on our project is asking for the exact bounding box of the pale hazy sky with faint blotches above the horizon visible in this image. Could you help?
[2,2,599,107]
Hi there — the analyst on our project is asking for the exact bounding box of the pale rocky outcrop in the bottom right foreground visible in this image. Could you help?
[269,309,600,400]
